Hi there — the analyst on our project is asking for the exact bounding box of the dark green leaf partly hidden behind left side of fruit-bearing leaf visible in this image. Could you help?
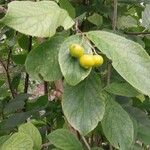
[25,36,63,81]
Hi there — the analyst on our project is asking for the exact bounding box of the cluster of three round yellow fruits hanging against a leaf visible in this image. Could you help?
[69,44,104,69]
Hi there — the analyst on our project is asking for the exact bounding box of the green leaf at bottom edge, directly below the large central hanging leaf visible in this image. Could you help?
[47,129,83,150]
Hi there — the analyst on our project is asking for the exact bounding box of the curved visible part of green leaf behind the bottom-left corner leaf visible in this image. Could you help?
[18,123,42,150]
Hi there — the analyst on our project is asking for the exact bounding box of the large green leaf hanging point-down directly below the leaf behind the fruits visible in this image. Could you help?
[62,74,105,135]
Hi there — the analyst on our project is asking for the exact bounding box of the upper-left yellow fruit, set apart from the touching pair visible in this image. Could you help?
[69,44,84,58]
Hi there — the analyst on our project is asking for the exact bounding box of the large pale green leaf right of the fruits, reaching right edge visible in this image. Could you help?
[87,31,150,95]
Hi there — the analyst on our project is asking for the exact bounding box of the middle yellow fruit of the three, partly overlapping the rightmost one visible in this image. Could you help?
[79,54,94,69]
